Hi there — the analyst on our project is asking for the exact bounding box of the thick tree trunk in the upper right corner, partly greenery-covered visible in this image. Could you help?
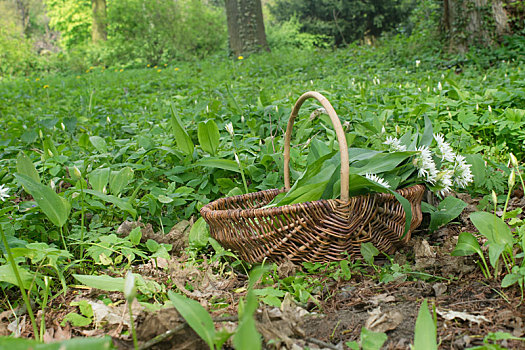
[443,0,511,53]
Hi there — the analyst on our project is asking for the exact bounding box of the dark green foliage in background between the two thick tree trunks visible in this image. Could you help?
[270,0,412,46]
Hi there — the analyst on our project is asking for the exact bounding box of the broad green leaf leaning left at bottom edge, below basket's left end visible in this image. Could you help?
[168,290,216,350]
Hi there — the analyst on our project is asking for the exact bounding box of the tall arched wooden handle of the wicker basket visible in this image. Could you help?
[284,91,350,202]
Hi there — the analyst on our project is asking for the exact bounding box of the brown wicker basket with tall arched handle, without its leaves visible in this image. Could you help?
[201,91,424,262]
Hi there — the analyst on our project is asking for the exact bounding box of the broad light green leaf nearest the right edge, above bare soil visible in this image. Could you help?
[470,211,514,247]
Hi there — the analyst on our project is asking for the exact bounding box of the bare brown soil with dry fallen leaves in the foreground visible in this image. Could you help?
[0,194,525,349]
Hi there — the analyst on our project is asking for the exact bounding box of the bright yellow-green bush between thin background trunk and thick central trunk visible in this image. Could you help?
[100,0,226,68]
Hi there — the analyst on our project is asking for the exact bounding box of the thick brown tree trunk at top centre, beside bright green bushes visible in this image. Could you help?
[225,0,270,56]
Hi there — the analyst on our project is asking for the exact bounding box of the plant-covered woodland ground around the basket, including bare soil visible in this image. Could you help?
[0,38,525,349]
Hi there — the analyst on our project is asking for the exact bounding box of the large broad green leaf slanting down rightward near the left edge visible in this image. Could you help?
[15,174,71,227]
